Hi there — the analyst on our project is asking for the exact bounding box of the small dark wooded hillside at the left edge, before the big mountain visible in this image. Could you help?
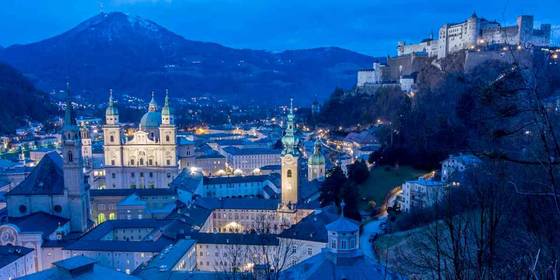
[0,63,56,134]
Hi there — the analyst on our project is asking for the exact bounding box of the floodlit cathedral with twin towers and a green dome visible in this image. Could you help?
[103,91,178,189]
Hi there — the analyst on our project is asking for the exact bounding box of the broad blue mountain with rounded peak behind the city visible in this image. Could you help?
[0,12,373,103]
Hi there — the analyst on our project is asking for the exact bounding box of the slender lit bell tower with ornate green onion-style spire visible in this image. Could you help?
[279,99,299,211]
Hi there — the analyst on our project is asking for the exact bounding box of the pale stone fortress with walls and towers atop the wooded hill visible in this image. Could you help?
[356,14,558,93]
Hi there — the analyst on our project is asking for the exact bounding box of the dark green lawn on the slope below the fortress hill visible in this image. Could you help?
[358,166,426,209]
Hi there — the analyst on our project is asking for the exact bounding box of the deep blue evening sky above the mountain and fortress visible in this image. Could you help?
[0,0,560,56]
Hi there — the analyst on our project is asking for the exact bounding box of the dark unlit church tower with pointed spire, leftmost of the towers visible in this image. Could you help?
[62,83,90,232]
